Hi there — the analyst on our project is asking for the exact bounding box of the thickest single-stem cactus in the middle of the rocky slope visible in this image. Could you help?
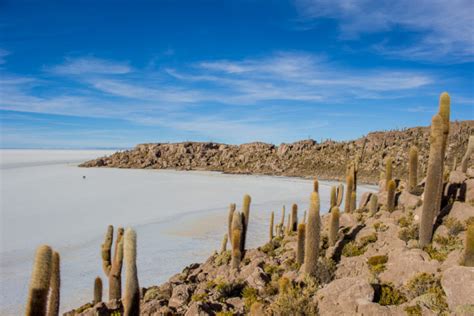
[304,192,321,276]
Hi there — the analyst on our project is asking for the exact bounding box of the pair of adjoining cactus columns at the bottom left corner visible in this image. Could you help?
[25,245,61,316]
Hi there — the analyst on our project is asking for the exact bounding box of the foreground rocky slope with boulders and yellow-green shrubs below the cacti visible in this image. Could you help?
[68,165,474,316]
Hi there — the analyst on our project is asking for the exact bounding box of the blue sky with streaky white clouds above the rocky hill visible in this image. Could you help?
[0,0,474,148]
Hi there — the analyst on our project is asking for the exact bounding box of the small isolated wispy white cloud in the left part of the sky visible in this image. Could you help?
[48,57,133,75]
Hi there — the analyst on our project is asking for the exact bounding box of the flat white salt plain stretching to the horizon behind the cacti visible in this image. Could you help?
[0,150,374,315]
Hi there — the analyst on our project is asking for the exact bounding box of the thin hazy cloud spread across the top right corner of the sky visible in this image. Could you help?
[296,0,474,62]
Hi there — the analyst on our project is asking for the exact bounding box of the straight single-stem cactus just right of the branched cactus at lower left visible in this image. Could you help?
[122,228,140,316]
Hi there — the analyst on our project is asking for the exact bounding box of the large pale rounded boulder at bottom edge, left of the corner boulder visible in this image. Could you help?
[316,278,374,315]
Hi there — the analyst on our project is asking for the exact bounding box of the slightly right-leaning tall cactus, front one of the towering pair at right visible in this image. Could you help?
[419,114,443,247]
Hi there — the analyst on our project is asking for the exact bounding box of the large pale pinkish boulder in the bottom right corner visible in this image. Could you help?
[441,266,474,311]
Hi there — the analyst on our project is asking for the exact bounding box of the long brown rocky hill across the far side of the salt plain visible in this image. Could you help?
[80,121,474,183]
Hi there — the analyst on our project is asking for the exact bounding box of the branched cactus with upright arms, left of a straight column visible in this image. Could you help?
[102,225,123,301]
